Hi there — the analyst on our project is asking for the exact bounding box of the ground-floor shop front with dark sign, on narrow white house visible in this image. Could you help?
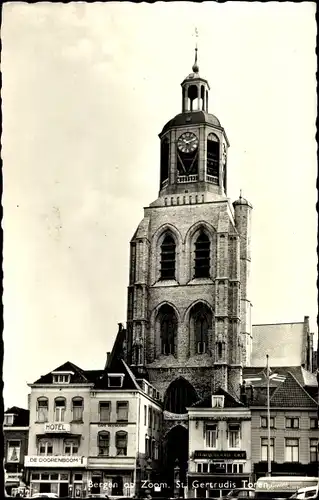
[187,450,251,498]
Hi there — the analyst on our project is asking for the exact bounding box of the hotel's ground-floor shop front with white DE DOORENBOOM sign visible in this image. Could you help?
[25,456,87,498]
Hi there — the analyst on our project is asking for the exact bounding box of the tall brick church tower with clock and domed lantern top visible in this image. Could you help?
[125,49,252,414]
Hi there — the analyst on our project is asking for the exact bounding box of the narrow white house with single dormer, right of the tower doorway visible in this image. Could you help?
[187,389,251,498]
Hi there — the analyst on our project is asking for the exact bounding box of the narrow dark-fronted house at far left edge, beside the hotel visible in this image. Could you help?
[3,406,29,495]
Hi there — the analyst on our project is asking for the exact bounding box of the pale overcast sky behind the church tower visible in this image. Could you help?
[2,2,317,407]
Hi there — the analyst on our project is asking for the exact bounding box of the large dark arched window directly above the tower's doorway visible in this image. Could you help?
[164,377,198,414]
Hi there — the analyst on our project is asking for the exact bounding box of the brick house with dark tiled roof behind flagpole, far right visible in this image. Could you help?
[245,368,319,480]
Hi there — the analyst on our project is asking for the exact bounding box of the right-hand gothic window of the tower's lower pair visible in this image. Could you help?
[190,303,212,355]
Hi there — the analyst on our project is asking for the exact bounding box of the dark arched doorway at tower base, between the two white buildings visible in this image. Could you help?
[164,425,188,490]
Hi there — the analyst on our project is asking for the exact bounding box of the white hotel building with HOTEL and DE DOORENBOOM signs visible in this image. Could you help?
[25,360,161,497]
